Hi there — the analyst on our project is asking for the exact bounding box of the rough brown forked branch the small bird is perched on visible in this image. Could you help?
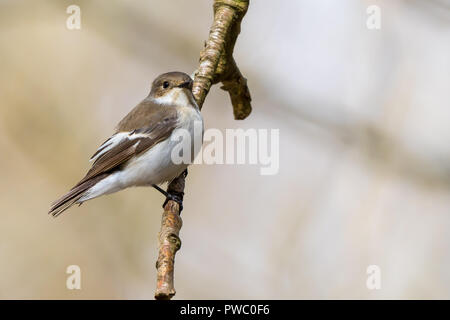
[155,0,252,300]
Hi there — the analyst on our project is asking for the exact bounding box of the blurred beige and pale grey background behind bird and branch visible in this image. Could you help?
[0,0,450,299]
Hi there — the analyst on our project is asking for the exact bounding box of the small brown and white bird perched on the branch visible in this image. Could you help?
[49,71,204,217]
